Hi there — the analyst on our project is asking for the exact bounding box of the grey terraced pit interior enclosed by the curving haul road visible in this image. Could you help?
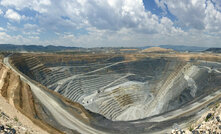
[9,54,221,121]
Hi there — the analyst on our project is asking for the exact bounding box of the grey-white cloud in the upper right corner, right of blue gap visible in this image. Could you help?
[155,0,221,34]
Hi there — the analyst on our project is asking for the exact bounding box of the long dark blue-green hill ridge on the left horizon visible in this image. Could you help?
[0,44,79,52]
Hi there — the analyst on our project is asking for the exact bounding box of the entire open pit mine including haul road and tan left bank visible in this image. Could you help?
[0,52,221,134]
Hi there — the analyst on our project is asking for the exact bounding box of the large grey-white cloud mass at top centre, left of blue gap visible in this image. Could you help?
[53,0,181,34]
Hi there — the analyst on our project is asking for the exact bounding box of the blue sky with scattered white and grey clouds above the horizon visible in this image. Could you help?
[0,0,221,47]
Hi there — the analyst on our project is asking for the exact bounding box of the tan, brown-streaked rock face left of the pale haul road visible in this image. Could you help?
[0,63,61,132]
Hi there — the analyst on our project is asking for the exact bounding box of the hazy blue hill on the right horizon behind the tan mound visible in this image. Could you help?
[159,45,208,52]
